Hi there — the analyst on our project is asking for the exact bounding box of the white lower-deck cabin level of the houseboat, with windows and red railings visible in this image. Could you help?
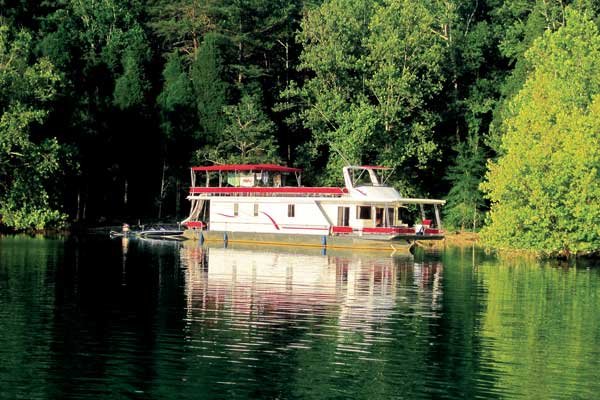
[184,196,443,242]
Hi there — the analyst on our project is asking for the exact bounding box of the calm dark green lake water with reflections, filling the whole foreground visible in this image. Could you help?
[0,236,600,399]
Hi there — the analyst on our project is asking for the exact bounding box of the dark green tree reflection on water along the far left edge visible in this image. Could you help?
[0,235,63,399]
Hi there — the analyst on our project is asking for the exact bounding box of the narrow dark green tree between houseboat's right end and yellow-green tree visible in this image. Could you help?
[444,136,485,231]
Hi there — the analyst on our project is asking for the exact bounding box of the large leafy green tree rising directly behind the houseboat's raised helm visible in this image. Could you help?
[293,0,444,187]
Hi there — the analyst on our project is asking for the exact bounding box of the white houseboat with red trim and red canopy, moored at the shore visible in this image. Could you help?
[182,164,444,250]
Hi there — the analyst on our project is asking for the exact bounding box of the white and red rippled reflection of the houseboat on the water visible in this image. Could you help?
[181,242,443,333]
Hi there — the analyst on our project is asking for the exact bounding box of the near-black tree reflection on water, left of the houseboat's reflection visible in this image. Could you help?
[51,238,190,398]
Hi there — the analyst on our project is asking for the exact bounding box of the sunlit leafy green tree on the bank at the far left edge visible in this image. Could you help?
[0,24,65,229]
